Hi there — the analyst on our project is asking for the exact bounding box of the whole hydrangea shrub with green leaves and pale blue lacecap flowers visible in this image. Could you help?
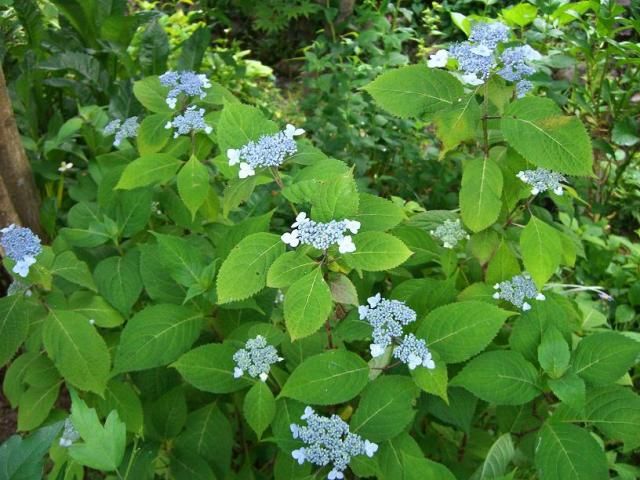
[0,16,640,480]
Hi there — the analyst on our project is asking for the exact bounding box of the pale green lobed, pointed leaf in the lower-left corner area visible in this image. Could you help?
[69,391,127,472]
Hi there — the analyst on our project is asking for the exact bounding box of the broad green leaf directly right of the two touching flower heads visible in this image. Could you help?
[416,301,515,363]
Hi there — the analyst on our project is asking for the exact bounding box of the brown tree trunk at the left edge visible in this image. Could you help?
[0,68,43,237]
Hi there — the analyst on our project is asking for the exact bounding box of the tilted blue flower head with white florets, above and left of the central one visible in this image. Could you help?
[227,124,304,178]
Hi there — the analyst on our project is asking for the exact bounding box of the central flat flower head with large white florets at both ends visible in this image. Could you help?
[280,212,360,253]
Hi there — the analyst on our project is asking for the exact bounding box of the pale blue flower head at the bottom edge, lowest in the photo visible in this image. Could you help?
[291,407,378,480]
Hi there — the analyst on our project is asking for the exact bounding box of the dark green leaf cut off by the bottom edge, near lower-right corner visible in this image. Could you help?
[535,421,609,480]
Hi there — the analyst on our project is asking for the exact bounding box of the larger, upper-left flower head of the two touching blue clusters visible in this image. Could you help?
[358,293,417,358]
